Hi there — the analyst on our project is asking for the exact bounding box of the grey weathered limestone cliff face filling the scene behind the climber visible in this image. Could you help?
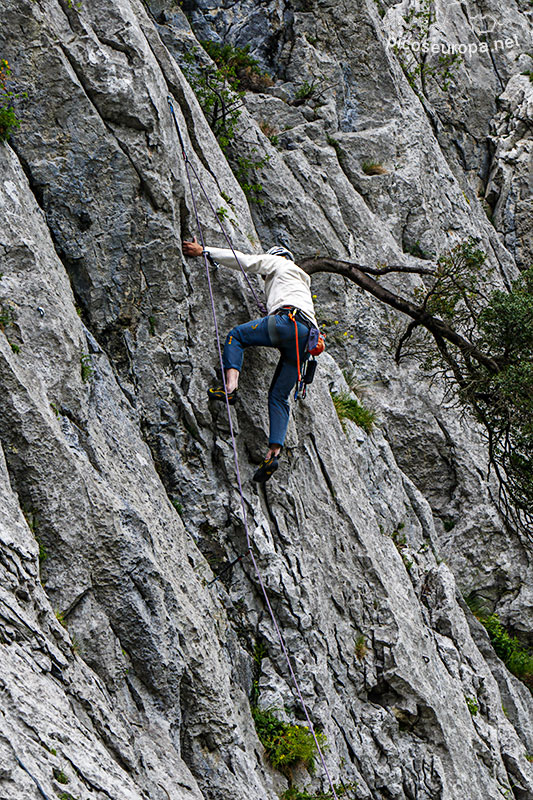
[0,0,533,800]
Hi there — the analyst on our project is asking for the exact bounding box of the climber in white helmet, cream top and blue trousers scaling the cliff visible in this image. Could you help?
[183,238,318,483]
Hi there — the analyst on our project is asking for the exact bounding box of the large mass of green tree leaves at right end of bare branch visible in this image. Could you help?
[396,238,533,529]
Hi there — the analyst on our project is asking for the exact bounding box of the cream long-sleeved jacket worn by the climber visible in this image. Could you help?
[205,247,318,327]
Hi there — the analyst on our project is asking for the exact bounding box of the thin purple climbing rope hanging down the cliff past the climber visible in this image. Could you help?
[167,97,339,800]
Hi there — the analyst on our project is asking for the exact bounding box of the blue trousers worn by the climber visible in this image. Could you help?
[223,313,309,446]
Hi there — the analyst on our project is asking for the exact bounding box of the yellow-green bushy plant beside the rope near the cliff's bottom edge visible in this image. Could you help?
[252,707,326,776]
